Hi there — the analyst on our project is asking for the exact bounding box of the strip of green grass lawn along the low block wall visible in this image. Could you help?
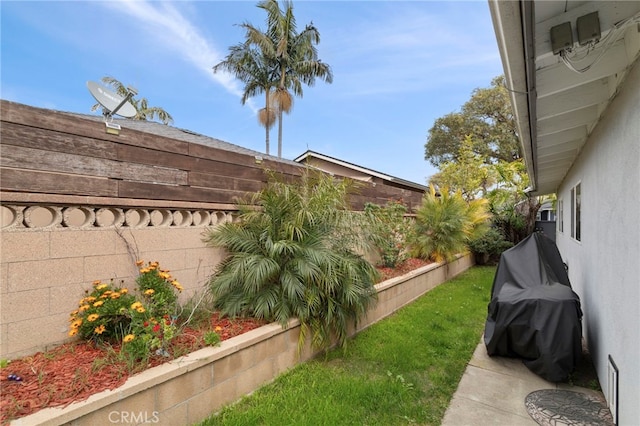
[201,267,495,426]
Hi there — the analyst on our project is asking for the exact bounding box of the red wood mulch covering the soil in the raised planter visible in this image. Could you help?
[0,259,430,424]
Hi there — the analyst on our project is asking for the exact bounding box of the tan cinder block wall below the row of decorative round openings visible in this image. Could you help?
[0,205,232,359]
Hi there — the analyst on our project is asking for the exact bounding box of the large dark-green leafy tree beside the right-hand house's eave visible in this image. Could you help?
[425,76,522,167]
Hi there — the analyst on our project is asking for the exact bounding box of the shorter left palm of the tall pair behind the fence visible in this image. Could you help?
[213,41,276,155]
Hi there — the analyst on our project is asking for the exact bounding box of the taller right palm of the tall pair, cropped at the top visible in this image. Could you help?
[258,0,333,157]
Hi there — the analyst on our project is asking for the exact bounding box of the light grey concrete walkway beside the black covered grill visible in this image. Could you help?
[442,341,602,426]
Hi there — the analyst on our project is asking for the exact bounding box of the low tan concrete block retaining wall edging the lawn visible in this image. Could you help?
[11,255,473,426]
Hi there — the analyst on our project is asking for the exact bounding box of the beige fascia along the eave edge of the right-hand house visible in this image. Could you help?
[489,0,538,192]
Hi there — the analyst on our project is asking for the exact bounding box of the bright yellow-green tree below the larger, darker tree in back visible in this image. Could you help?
[430,135,495,201]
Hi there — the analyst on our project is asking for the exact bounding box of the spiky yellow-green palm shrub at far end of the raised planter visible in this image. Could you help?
[410,185,490,262]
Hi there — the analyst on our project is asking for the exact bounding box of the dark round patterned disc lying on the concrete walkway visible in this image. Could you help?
[524,389,614,426]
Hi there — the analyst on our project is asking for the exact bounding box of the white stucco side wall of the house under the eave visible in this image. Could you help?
[556,61,640,425]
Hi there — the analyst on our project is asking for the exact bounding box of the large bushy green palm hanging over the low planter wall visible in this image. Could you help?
[205,170,377,347]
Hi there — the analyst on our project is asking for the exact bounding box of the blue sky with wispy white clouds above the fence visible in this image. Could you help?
[0,0,502,184]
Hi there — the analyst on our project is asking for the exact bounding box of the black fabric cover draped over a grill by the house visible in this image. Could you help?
[484,232,582,382]
